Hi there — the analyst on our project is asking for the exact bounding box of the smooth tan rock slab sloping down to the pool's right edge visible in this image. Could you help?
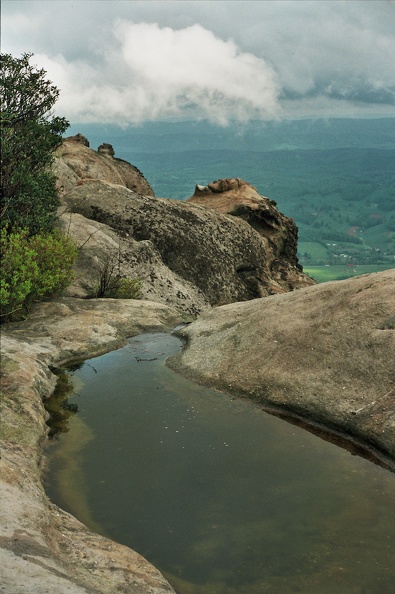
[171,270,395,464]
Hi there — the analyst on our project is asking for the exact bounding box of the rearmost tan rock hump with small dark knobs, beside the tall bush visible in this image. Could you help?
[54,134,154,196]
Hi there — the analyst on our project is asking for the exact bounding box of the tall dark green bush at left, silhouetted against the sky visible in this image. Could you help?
[0,54,69,235]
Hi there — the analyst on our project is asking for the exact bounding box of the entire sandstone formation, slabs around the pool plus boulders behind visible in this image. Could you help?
[0,135,395,594]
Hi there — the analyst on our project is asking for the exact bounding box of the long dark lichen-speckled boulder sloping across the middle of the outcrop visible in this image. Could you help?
[63,181,314,311]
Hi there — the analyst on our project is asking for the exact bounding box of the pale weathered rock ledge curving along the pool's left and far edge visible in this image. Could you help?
[0,299,179,594]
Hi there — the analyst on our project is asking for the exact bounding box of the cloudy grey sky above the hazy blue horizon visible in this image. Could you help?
[1,0,395,125]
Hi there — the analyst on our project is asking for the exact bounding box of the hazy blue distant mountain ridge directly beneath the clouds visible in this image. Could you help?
[71,118,395,152]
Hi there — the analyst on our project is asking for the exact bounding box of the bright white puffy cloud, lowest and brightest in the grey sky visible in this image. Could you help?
[34,20,279,125]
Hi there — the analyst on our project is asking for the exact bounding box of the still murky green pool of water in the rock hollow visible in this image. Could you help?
[46,334,395,594]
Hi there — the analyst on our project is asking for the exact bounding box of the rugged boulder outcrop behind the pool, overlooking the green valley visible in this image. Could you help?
[56,134,314,318]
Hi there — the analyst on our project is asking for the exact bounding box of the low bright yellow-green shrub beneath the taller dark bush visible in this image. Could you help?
[0,229,77,322]
